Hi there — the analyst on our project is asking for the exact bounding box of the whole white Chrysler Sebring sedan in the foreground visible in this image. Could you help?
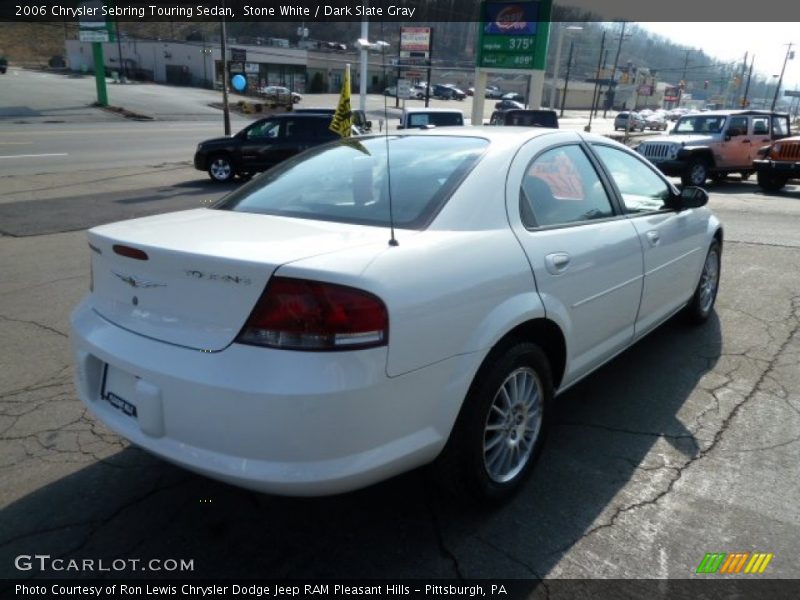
[72,127,722,501]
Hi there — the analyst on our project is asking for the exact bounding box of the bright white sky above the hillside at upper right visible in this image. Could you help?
[638,22,800,89]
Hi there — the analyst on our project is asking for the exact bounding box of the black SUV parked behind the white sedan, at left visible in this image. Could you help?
[194,113,346,182]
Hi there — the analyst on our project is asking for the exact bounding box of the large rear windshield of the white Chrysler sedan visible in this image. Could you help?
[215,136,489,229]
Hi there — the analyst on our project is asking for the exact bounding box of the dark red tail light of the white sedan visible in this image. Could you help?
[236,277,389,350]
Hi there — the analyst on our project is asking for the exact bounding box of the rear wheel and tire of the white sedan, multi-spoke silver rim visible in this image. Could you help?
[434,342,553,506]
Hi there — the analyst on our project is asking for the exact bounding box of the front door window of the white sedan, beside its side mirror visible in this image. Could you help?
[592,144,672,213]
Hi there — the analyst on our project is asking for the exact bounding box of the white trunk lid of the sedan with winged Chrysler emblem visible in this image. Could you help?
[88,209,386,351]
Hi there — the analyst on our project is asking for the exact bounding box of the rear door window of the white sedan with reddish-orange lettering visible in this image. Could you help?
[520,145,614,227]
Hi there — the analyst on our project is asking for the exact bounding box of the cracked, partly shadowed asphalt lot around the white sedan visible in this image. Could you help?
[0,167,800,589]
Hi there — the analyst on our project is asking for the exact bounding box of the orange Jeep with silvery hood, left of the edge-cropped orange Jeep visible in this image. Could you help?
[637,110,790,185]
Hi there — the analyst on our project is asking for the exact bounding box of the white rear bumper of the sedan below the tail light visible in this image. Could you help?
[72,300,472,496]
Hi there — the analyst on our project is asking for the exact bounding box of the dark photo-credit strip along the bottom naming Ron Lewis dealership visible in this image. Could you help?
[0,574,800,600]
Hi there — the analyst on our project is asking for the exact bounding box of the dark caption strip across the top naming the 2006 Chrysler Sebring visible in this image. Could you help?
[0,0,800,21]
